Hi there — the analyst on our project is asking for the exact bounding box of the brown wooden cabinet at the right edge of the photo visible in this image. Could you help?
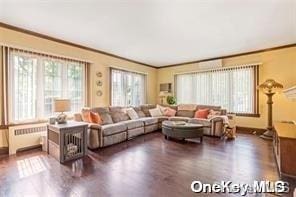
[273,122,296,178]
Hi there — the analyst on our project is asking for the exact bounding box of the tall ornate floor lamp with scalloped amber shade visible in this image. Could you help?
[259,79,283,139]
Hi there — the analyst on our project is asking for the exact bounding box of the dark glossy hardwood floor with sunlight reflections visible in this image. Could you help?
[0,132,295,197]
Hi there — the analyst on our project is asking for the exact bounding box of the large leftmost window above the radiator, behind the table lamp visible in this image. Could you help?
[9,49,85,122]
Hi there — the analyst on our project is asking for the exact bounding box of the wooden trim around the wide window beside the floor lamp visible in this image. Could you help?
[173,63,261,118]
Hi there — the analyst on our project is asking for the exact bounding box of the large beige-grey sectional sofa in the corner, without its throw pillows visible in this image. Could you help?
[74,104,226,149]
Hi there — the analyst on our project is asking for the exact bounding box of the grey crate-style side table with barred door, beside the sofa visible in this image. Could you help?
[47,121,88,163]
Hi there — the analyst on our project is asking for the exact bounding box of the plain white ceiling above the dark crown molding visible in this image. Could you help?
[0,0,296,67]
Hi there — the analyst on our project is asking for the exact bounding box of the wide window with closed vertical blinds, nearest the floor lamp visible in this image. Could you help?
[175,66,258,114]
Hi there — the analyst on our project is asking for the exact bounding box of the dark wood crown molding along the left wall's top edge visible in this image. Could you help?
[0,22,158,68]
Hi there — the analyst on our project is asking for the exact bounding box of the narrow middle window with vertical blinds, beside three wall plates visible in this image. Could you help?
[111,68,146,106]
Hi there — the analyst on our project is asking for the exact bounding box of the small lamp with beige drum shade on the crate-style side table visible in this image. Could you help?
[54,99,71,124]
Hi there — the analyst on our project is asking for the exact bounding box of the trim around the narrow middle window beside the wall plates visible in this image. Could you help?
[109,66,148,106]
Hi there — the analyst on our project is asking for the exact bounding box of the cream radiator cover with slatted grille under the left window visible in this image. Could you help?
[8,123,47,155]
